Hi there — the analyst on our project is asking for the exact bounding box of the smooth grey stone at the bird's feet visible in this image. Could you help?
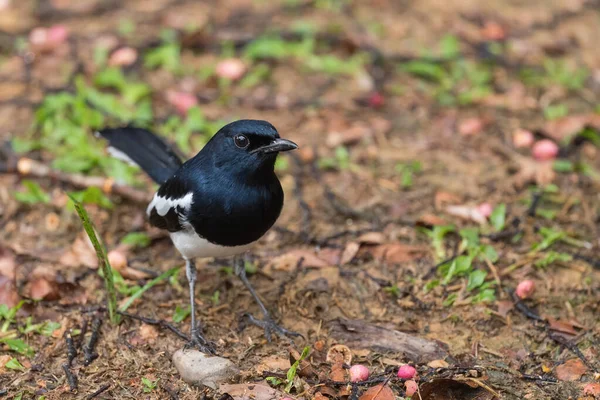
[173,350,240,389]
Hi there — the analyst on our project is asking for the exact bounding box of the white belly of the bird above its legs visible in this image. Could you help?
[170,230,256,259]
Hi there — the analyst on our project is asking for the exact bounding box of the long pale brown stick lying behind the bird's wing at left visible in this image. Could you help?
[0,157,152,203]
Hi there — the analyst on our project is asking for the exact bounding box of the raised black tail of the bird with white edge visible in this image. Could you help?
[96,127,182,184]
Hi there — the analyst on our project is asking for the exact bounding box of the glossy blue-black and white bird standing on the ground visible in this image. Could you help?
[96,119,301,354]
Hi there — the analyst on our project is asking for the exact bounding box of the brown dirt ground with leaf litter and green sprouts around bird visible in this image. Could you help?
[0,0,600,400]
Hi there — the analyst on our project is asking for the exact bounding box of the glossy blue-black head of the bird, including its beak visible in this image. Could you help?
[202,119,298,173]
